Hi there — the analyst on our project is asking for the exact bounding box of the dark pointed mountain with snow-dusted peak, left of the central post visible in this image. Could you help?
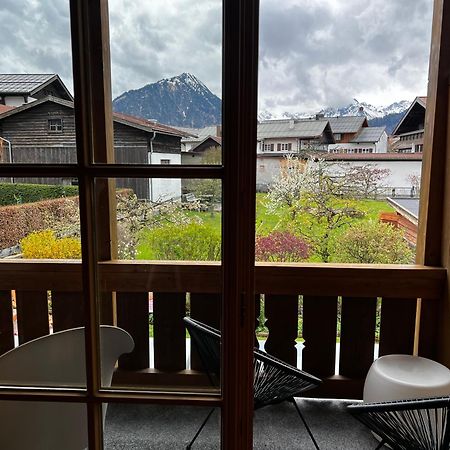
[113,73,221,128]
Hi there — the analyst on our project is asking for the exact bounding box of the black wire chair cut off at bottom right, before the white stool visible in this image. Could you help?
[347,397,450,450]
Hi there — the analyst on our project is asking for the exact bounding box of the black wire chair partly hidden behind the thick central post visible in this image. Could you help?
[184,317,322,449]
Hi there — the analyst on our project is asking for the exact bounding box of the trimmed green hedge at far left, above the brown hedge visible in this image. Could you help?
[0,183,78,206]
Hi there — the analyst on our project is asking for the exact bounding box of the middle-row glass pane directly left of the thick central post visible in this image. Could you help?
[95,178,222,392]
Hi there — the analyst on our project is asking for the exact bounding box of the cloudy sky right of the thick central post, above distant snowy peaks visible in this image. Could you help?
[259,0,431,112]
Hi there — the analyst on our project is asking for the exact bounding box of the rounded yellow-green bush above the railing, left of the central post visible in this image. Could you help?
[137,223,220,261]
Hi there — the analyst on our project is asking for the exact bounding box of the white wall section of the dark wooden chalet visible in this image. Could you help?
[148,152,181,202]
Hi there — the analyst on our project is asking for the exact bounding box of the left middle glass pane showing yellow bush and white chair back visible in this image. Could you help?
[0,178,85,386]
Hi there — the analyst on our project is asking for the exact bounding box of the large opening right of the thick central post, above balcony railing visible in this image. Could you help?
[256,0,432,264]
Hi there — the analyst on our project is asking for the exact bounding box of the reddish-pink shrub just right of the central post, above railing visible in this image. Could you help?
[255,231,310,262]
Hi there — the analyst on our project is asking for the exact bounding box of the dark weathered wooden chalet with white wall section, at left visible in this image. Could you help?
[0,96,191,201]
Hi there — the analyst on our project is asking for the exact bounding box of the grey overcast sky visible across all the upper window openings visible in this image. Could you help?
[0,0,432,114]
